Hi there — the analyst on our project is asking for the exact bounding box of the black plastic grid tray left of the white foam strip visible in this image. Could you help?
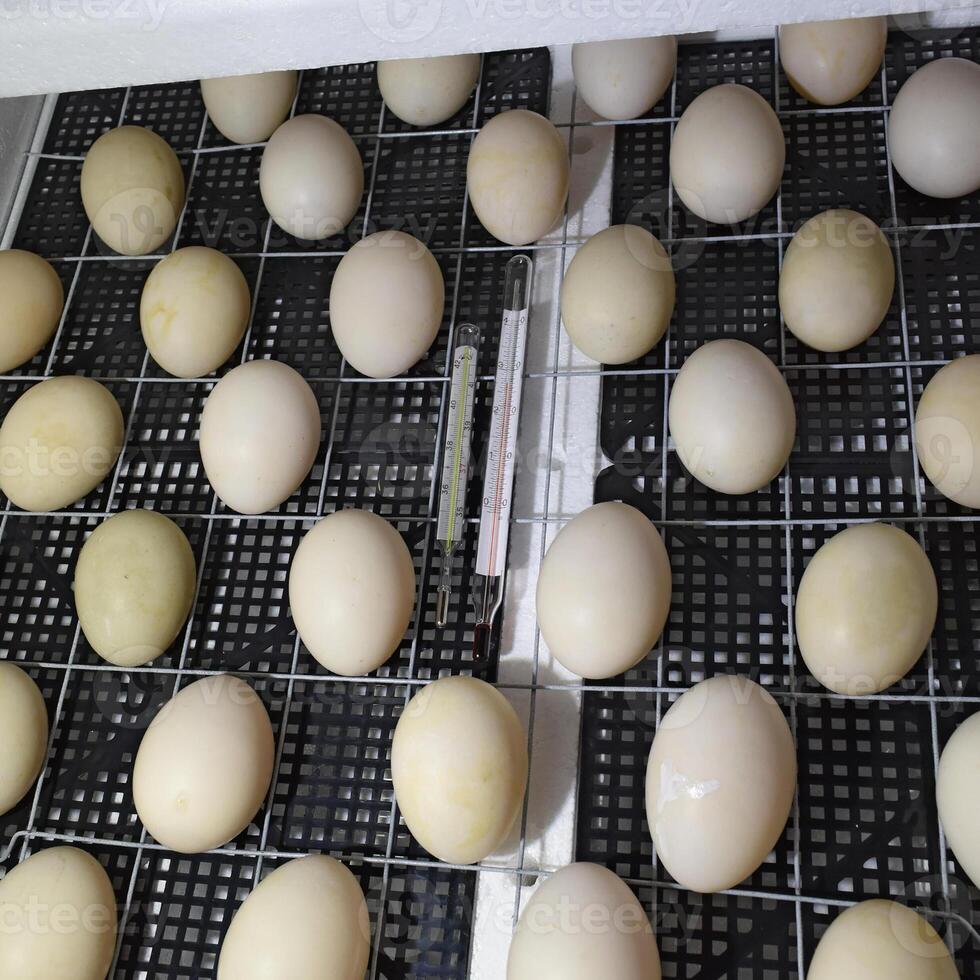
[0,49,551,980]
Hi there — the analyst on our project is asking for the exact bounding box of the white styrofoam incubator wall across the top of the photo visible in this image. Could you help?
[0,0,977,97]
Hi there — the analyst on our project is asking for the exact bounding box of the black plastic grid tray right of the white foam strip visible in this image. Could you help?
[577,28,980,980]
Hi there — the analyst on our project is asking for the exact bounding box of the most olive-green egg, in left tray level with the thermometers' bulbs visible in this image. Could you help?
[74,510,197,667]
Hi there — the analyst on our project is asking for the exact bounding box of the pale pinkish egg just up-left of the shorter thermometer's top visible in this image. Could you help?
[330,231,446,378]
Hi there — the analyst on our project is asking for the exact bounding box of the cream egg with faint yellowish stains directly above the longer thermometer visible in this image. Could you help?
[466,109,568,245]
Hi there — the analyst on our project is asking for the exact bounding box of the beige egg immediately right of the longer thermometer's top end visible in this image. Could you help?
[561,225,675,364]
